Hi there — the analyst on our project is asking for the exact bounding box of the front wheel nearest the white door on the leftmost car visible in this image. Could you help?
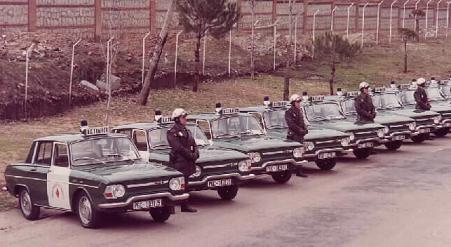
[75,192,100,228]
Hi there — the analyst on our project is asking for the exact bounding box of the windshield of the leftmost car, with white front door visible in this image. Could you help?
[70,137,139,166]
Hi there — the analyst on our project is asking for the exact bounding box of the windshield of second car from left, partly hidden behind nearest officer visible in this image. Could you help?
[149,125,209,148]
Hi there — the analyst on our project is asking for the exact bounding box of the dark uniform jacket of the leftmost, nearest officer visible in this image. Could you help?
[167,123,199,177]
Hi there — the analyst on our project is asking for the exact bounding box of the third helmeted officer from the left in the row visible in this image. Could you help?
[355,82,376,122]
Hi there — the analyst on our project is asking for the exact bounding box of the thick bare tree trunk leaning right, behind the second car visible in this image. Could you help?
[138,0,175,105]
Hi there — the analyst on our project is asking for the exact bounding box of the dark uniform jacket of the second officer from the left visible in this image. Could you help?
[285,106,308,142]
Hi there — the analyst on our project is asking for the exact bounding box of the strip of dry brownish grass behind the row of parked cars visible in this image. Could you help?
[0,38,451,210]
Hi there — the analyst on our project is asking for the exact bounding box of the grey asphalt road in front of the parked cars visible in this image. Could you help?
[0,137,451,247]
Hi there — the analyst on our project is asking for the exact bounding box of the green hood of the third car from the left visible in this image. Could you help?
[214,136,302,152]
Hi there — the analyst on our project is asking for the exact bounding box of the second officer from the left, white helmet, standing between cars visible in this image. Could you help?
[285,94,308,177]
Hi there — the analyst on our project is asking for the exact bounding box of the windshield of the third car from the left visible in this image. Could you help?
[211,115,263,138]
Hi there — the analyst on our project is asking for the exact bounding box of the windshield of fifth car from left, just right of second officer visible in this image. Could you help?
[304,103,345,121]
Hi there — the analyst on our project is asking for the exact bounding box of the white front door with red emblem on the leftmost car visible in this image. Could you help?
[47,142,71,210]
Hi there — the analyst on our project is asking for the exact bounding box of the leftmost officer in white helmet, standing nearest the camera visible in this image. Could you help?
[167,108,199,213]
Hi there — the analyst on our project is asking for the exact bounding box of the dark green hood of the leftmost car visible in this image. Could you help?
[74,160,182,183]
